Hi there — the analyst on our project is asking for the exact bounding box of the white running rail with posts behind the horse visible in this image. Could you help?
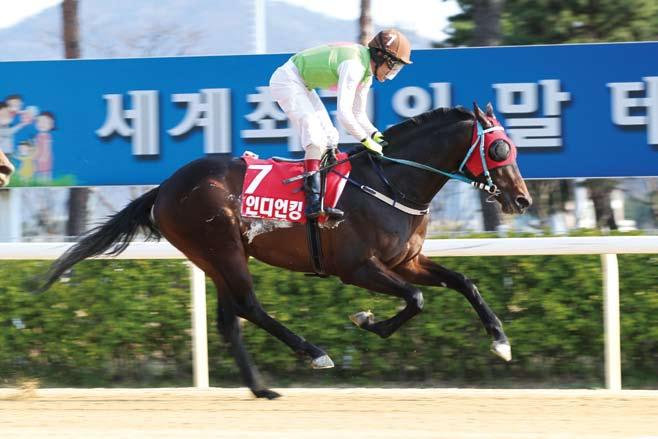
[0,236,658,390]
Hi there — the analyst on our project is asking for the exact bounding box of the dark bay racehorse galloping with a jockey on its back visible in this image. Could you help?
[46,105,531,398]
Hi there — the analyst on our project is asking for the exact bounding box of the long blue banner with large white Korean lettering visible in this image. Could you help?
[0,42,658,186]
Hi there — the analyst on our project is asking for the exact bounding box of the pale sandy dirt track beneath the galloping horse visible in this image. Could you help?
[0,389,658,439]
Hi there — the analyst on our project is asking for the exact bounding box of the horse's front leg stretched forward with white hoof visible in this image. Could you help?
[394,254,512,361]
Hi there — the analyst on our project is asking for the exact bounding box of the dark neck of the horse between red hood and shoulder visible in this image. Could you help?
[386,124,470,203]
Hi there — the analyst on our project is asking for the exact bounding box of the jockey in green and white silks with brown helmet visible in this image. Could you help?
[270,29,411,219]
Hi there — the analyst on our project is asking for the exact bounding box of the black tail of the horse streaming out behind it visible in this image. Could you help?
[41,187,161,291]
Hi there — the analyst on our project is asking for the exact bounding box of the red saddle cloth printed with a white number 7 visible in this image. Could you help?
[241,153,352,224]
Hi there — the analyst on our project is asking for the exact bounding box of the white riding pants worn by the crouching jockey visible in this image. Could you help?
[270,60,338,160]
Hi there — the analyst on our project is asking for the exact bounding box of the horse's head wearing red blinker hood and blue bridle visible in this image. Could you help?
[465,103,532,213]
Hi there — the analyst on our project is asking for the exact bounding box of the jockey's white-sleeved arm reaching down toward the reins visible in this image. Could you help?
[336,60,371,141]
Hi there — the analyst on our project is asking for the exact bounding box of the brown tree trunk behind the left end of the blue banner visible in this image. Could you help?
[62,0,89,236]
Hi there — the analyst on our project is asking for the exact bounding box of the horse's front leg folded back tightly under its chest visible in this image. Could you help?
[341,257,423,338]
